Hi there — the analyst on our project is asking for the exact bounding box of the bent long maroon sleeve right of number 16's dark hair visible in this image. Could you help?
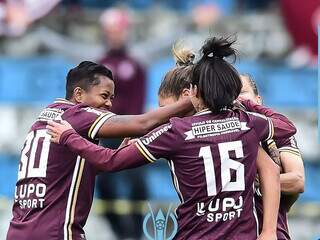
[241,100,297,139]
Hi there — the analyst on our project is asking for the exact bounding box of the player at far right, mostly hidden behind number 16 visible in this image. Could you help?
[240,74,304,240]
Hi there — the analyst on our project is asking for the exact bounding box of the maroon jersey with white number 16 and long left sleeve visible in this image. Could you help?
[60,110,296,240]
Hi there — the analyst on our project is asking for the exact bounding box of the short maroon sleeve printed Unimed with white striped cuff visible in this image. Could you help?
[135,123,179,162]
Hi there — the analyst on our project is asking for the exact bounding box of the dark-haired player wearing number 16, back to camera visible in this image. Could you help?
[47,38,295,240]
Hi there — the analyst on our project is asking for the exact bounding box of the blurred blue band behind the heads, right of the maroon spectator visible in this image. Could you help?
[147,58,318,108]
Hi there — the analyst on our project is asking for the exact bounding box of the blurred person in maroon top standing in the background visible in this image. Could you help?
[98,9,147,239]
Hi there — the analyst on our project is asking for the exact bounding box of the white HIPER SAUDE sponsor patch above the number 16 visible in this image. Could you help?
[185,118,250,140]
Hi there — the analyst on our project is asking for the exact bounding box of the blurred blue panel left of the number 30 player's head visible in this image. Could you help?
[0,56,75,104]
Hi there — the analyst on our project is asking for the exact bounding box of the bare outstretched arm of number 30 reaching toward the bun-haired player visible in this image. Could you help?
[97,98,193,138]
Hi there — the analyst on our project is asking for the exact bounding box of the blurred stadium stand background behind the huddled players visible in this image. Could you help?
[0,0,320,240]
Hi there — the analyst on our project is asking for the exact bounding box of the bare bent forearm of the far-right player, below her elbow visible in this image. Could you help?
[280,172,304,194]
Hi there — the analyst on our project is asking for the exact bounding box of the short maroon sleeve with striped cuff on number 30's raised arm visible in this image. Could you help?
[62,105,115,139]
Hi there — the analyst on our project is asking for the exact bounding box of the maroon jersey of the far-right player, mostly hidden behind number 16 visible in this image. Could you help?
[255,136,300,240]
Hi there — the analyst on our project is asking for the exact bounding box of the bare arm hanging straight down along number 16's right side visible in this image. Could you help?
[257,147,280,240]
